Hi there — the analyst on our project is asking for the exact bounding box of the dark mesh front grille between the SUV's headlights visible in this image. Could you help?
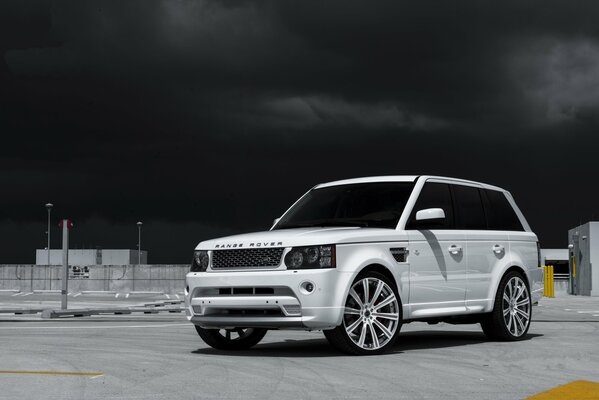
[212,247,285,269]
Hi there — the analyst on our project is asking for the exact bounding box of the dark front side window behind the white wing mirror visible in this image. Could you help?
[406,183,453,229]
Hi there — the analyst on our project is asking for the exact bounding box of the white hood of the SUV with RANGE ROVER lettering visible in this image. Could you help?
[196,227,408,250]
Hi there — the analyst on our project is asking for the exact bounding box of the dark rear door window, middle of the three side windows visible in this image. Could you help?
[452,185,487,229]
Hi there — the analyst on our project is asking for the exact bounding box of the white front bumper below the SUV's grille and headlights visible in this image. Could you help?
[185,269,352,329]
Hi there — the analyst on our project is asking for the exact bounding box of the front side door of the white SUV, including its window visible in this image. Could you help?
[406,181,467,318]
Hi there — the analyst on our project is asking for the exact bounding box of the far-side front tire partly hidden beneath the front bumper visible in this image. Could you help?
[196,325,268,350]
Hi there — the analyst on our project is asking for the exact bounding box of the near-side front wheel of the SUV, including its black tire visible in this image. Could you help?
[324,271,402,355]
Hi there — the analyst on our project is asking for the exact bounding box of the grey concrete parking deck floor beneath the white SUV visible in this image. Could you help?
[0,296,599,400]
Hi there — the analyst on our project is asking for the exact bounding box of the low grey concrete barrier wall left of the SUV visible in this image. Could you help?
[0,264,189,293]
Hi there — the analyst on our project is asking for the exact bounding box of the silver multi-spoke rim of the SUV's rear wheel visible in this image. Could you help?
[502,276,531,337]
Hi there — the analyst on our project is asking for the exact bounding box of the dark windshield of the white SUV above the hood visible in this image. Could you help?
[274,182,414,229]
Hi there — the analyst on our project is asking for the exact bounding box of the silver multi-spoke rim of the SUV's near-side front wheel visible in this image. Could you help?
[343,277,400,350]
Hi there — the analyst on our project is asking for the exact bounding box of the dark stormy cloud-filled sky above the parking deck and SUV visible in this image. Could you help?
[0,1,599,261]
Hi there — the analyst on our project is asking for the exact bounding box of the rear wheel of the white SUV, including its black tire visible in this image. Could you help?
[480,271,532,341]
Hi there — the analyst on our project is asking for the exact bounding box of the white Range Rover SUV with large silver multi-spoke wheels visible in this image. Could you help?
[185,176,543,354]
